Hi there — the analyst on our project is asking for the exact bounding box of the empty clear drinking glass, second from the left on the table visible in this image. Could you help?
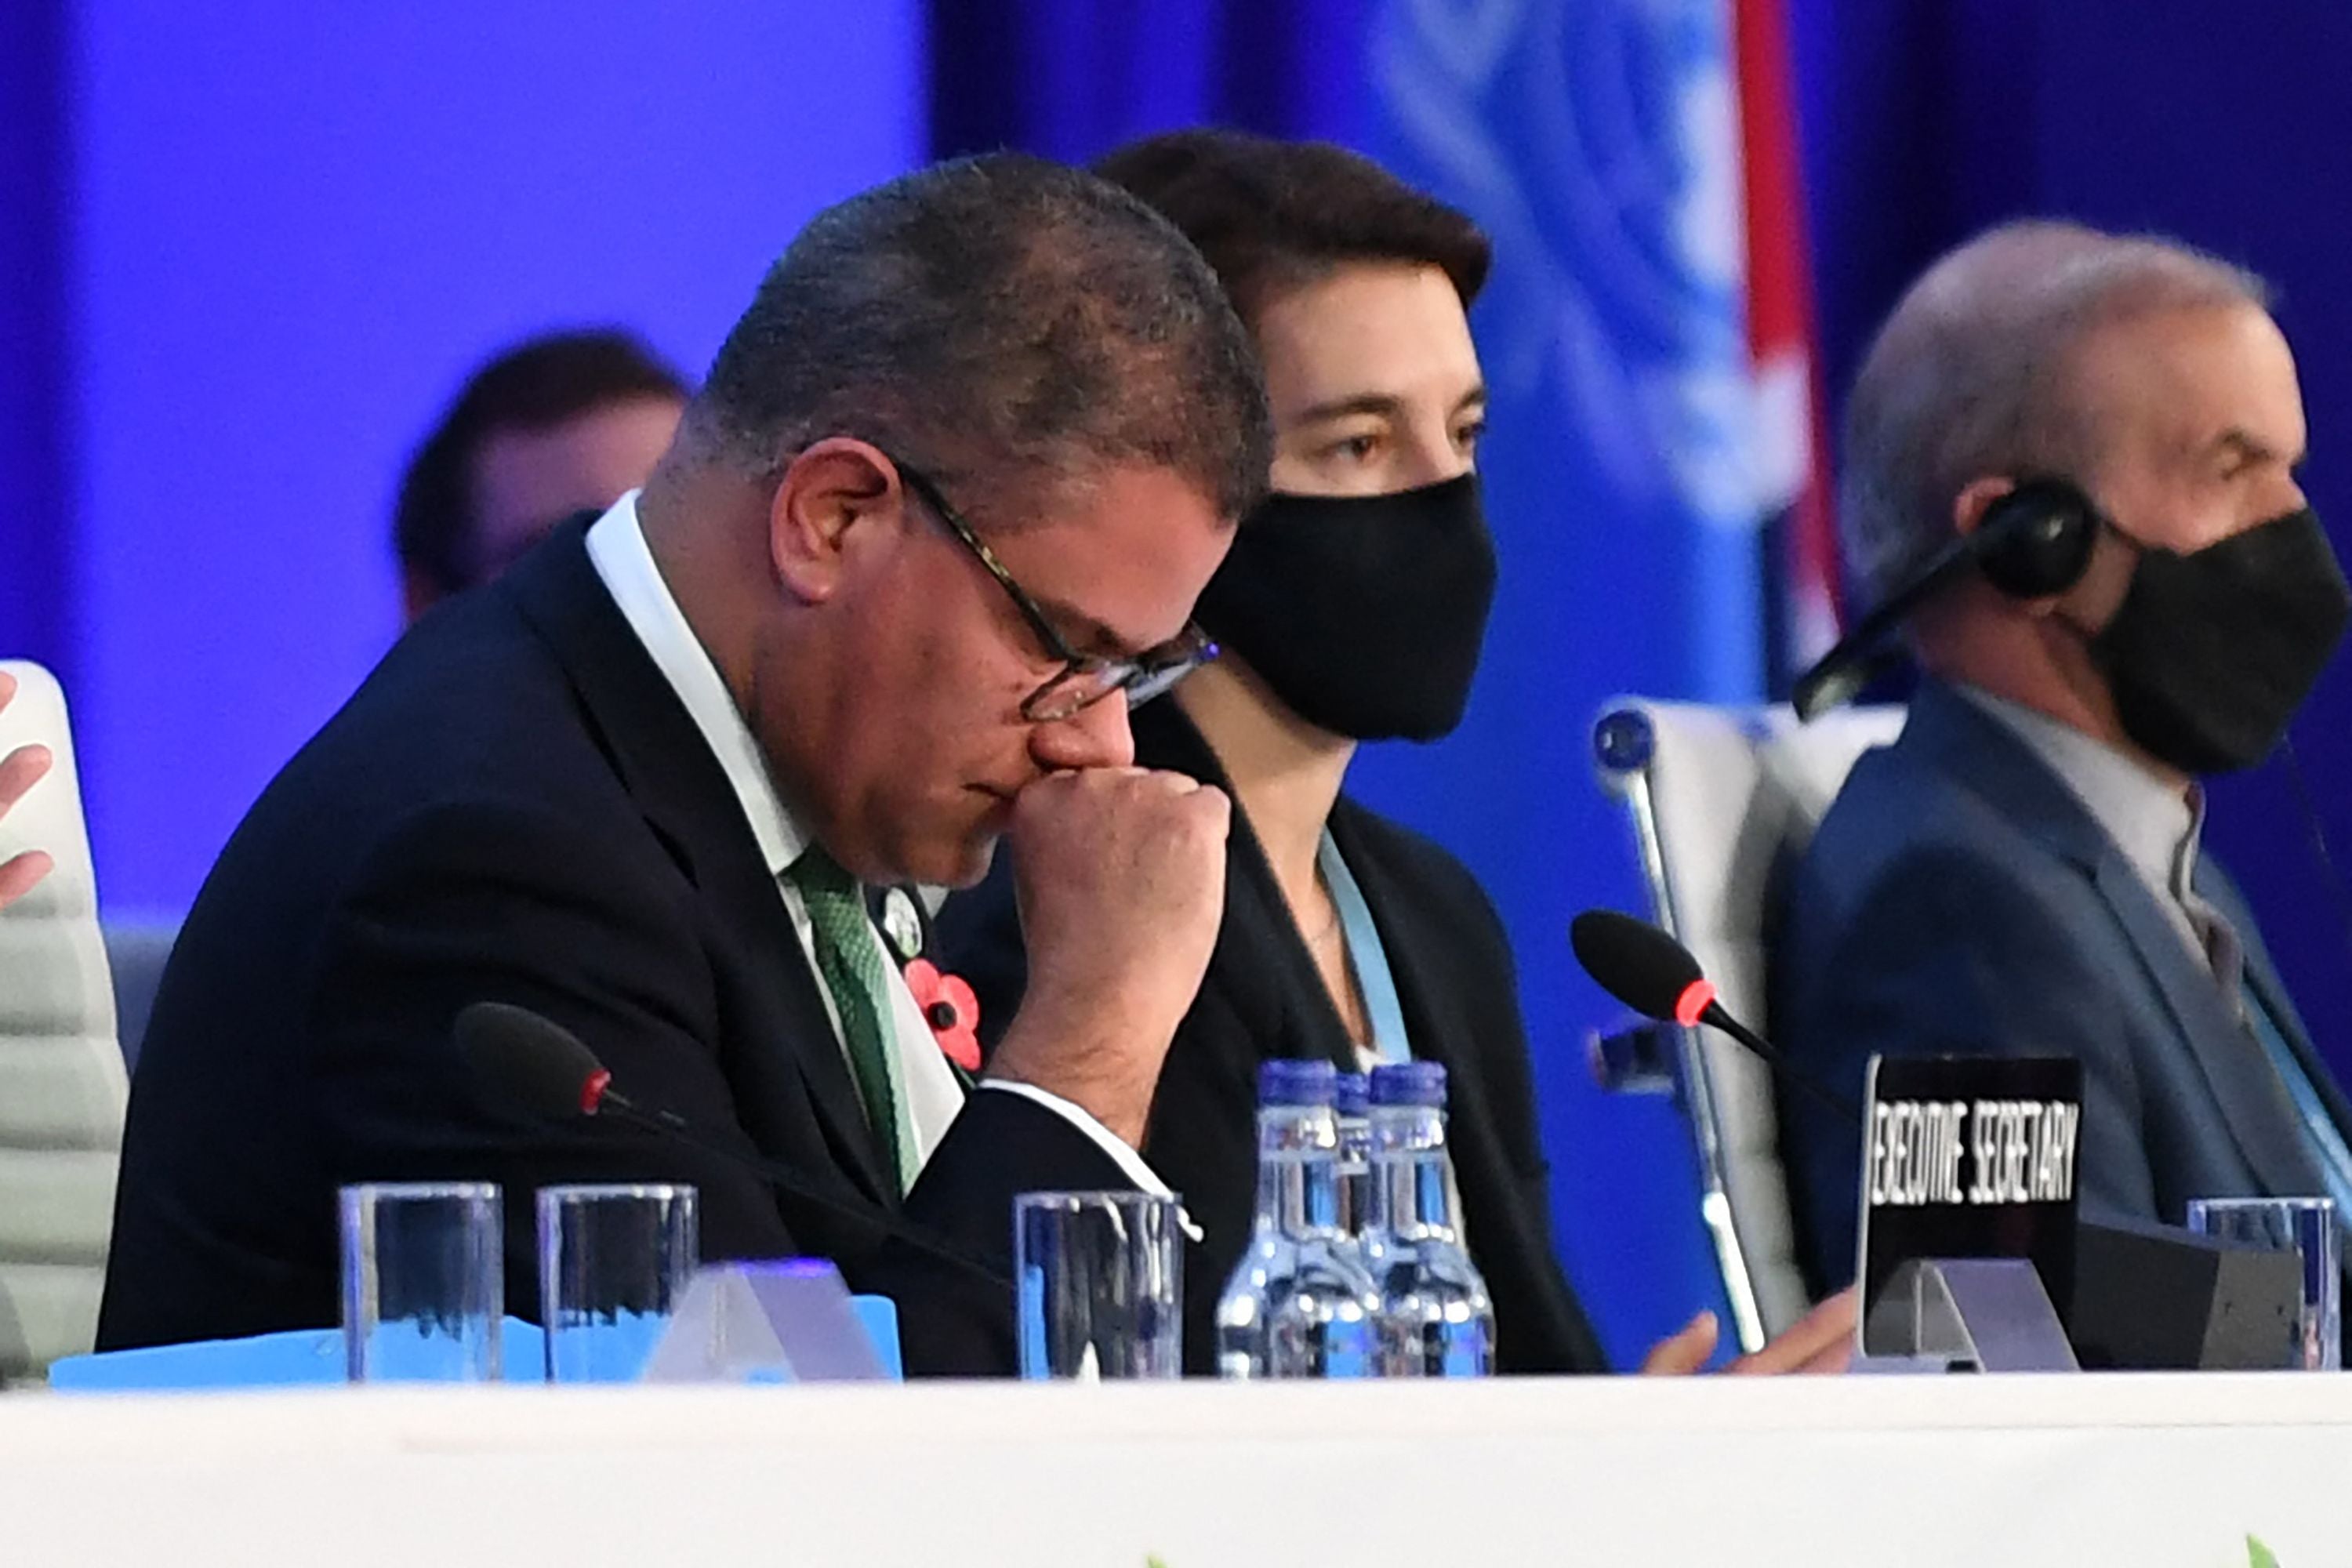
[539,1182,696,1382]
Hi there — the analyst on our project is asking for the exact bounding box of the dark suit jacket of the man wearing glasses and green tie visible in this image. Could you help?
[99,522,1124,1373]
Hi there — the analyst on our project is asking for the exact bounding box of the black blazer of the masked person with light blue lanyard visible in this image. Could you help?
[938,703,1609,1373]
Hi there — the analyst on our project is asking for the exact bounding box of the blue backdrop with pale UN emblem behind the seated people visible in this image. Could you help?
[13,0,2352,1356]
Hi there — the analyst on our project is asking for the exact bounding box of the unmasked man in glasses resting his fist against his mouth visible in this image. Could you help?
[101,155,1270,1373]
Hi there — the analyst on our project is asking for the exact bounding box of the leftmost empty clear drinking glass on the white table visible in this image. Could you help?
[341,1182,506,1382]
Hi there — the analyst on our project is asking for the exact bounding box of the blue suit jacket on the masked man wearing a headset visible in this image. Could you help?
[1769,682,2352,1286]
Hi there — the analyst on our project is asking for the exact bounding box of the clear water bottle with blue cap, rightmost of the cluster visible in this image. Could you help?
[1362,1062,1494,1377]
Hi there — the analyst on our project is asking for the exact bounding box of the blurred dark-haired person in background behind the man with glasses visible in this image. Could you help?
[393,327,687,621]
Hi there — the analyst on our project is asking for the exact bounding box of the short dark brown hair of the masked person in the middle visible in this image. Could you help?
[1094,129,1494,325]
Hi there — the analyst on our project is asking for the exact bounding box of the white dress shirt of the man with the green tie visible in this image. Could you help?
[588,492,1167,1194]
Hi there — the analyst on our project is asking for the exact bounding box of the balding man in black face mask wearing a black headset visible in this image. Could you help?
[1771,223,2352,1316]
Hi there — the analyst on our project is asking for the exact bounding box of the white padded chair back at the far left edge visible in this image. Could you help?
[0,661,129,1380]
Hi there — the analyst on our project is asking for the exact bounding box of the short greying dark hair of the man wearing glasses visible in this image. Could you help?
[687,153,1272,524]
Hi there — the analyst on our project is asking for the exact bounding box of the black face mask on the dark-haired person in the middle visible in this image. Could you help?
[1195,475,1494,741]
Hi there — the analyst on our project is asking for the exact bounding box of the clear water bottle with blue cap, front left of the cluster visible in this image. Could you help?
[1216,1062,1381,1377]
